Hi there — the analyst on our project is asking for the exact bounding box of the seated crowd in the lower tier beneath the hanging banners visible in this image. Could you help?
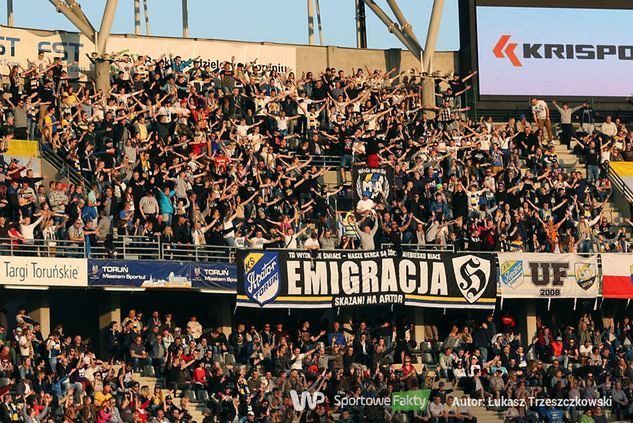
[0,309,633,423]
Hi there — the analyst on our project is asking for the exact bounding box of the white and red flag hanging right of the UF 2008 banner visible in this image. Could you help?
[602,254,633,299]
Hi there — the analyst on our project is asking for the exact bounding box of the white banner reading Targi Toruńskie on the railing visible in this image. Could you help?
[0,256,88,287]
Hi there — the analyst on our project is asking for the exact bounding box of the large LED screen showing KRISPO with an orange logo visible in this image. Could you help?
[476,6,633,97]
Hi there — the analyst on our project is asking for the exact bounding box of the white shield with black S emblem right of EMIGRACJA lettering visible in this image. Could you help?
[453,254,492,304]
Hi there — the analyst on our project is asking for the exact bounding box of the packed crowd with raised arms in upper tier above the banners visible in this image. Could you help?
[0,53,633,255]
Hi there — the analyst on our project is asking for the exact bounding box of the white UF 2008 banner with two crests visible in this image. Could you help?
[499,253,600,298]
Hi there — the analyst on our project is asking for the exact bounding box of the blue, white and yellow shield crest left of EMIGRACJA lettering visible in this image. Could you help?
[244,252,281,307]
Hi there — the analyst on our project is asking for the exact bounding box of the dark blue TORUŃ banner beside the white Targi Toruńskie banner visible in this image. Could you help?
[88,260,237,293]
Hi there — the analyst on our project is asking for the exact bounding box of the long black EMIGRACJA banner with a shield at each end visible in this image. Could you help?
[236,250,497,309]
